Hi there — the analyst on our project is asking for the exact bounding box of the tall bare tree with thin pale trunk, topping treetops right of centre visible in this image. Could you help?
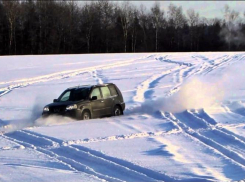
[151,2,164,52]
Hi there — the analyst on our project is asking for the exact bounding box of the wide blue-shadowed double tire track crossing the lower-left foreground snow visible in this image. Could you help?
[3,130,177,181]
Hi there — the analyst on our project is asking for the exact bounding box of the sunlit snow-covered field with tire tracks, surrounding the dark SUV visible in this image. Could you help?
[0,52,245,182]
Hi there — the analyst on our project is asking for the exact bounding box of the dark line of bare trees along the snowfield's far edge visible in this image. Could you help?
[0,0,245,55]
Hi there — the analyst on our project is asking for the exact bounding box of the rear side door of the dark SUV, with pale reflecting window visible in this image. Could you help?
[100,86,113,115]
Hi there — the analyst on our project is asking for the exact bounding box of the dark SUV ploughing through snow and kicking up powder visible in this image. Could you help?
[42,83,125,120]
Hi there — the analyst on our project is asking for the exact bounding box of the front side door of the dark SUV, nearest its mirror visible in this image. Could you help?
[90,87,105,118]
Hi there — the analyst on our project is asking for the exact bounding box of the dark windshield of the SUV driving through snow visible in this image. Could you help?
[58,87,90,102]
